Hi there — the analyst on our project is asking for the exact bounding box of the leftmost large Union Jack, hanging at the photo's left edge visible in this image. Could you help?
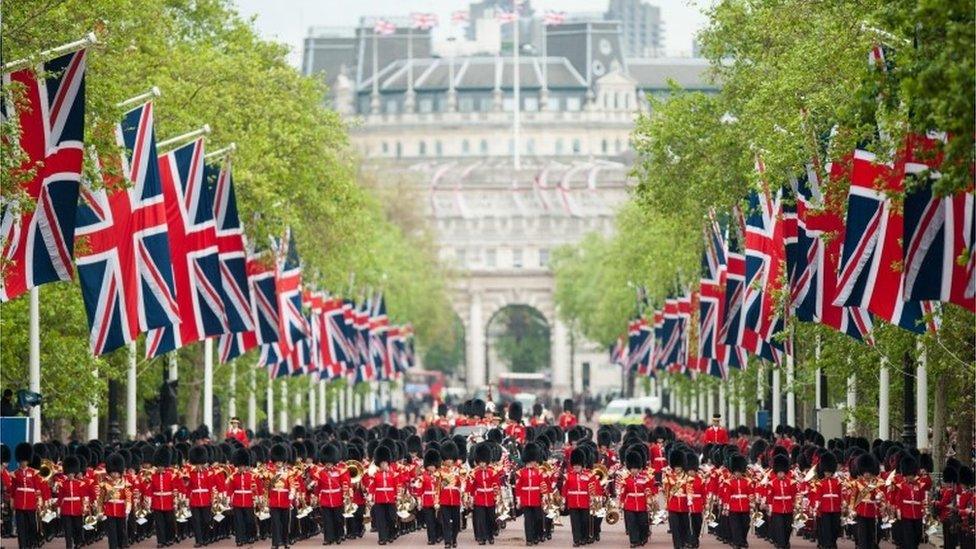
[0,50,87,302]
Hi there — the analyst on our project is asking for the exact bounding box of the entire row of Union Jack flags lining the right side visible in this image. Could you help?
[611,49,976,378]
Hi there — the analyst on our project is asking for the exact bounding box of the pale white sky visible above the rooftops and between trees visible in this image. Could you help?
[234,0,708,67]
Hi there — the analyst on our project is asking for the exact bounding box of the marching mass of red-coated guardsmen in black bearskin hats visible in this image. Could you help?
[0,400,974,549]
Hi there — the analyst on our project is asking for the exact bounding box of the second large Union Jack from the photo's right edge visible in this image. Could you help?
[834,150,936,333]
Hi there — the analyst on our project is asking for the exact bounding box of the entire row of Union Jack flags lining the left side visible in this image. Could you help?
[0,45,414,381]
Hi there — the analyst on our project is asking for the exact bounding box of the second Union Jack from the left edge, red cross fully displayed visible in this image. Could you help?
[75,103,180,356]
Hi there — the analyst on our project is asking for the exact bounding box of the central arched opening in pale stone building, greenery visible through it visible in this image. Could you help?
[485,304,552,384]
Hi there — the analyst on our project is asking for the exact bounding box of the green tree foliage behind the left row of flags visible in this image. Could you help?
[0,0,452,436]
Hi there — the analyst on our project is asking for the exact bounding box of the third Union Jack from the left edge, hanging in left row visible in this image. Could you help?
[146,138,230,357]
